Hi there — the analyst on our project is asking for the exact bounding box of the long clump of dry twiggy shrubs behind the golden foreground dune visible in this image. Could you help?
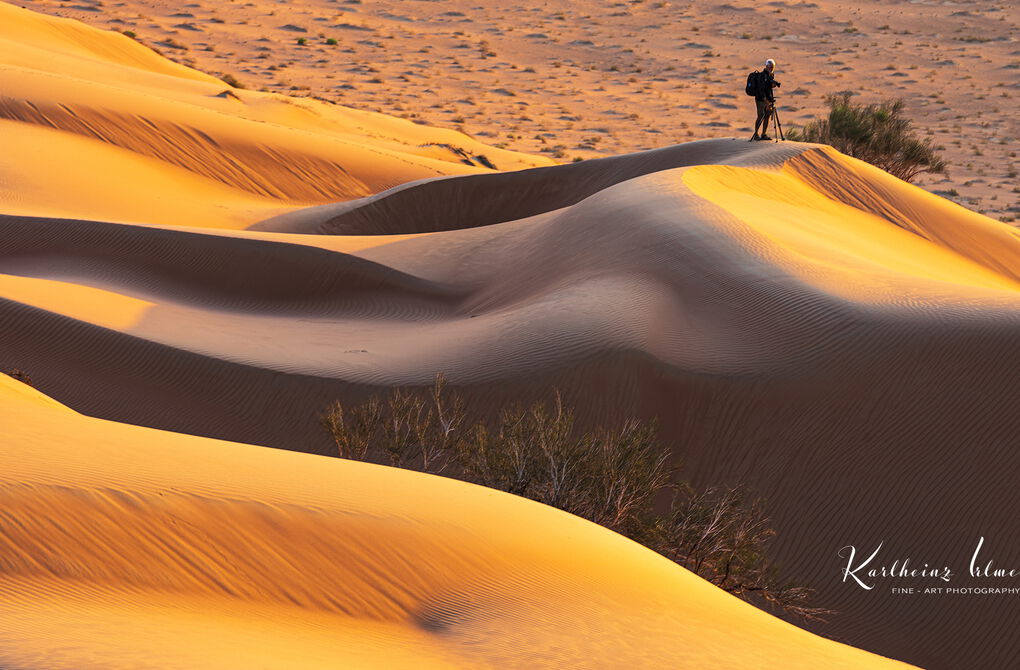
[319,374,828,619]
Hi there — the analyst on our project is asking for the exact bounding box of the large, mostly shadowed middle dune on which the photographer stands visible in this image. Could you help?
[0,140,1020,669]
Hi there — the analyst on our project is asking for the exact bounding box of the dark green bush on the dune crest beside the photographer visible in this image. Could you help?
[787,92,947,182]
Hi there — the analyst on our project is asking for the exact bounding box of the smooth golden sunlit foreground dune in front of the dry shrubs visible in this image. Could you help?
[0,375,908,670]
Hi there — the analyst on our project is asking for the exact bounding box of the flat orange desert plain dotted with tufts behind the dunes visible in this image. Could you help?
[26,0,1020,221]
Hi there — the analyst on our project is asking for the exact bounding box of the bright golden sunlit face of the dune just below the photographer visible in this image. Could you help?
[683,149,1020,301]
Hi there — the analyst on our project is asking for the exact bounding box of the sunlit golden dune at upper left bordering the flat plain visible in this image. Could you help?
[0,3,552,228]
